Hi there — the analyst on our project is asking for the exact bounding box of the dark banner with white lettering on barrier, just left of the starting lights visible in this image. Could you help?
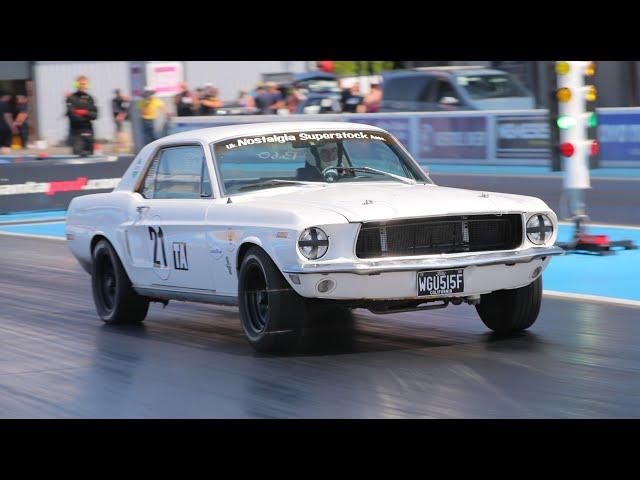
[496,115,551,160]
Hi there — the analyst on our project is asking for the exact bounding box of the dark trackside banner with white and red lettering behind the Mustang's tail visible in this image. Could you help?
[0,155,133,214]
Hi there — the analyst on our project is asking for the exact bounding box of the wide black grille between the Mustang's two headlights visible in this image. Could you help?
[356,214,522,258]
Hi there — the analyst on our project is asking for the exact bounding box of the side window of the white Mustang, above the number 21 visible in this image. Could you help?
[140,145,212,199]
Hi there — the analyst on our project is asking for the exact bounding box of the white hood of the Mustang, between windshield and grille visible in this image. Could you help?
[234,182,549,222]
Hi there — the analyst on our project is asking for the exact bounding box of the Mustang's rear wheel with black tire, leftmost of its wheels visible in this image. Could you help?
[91,240,149,324]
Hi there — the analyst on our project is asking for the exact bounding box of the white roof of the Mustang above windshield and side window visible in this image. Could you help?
[153,121,384,145]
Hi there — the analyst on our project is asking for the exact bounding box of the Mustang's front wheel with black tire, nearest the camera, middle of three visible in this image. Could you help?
[238,247,308,353]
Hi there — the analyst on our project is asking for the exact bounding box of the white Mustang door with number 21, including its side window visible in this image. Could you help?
[127,144,213,292]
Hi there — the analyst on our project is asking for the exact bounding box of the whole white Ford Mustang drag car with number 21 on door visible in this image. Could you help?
[66,122,563,351]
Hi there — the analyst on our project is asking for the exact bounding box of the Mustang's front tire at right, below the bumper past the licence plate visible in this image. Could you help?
[476,277,542,334]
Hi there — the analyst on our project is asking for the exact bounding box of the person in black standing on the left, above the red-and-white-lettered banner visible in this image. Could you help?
[67,75,98,157]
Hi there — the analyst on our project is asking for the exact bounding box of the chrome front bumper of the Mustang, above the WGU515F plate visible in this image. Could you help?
[282,246,565,275]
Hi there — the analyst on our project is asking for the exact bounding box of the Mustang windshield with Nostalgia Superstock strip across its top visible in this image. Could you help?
[212,130,431,195]
